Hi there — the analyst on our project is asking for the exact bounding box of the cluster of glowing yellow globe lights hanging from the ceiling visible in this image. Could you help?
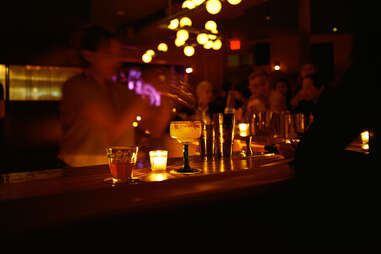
[142,0,242,63]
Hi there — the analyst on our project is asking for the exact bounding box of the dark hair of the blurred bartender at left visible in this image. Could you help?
[78,25,117,67]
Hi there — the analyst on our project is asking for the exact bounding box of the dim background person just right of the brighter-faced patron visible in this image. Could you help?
[269,78,290,112]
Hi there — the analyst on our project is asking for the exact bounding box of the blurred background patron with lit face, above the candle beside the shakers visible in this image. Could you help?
[247,70,271,112]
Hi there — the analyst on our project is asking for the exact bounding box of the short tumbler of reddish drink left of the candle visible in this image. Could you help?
[104,146,139,185]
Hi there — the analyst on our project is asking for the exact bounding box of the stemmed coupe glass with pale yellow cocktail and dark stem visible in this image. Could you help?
[169,121,201,174]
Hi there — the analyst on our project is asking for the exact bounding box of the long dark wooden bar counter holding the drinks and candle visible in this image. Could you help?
[0,154,293,245]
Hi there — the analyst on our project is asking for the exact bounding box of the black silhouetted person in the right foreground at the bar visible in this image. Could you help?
[272,12,381,248]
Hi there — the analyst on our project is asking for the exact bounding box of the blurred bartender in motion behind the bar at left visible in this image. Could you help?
[58,26,151,167]
